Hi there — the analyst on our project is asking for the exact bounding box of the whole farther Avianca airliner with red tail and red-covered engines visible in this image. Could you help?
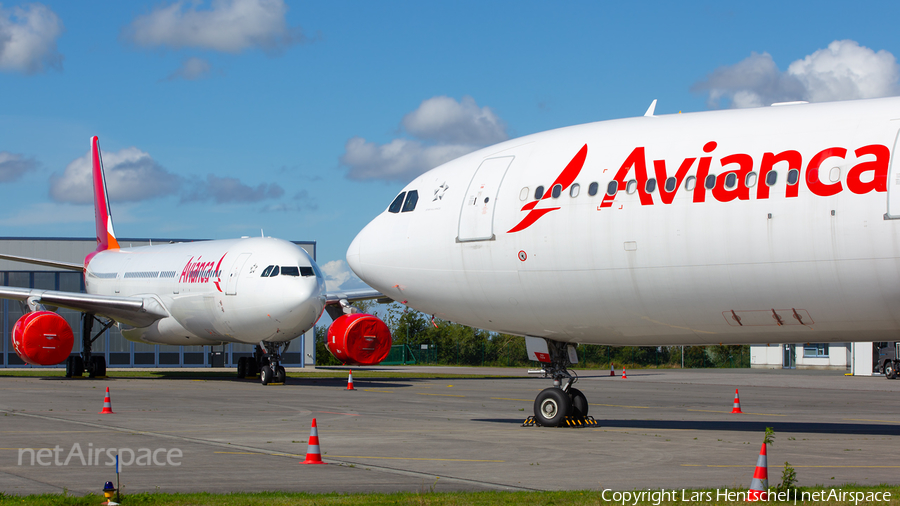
[0,137,391,385]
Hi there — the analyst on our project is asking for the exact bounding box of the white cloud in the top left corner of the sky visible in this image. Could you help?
[0,3,64,74]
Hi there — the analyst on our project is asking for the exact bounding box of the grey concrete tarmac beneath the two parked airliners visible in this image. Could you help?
[0,367,900,494]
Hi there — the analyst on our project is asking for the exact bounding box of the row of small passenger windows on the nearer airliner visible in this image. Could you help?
[516,169,800,202]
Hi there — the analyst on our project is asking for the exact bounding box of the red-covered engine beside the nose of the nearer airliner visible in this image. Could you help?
[328,313,392,365]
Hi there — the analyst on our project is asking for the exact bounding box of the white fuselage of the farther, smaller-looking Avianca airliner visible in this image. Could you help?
[85,237,325,345]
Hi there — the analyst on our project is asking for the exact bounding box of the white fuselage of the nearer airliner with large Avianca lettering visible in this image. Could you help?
[347,98,900,345]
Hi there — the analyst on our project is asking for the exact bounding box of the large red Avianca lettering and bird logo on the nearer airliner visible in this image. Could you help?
[508,141,891,233]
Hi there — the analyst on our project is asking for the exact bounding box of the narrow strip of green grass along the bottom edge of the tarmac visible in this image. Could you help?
[0,485,900,506]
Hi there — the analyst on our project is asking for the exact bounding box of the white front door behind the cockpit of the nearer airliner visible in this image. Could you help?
[457,156,515,242]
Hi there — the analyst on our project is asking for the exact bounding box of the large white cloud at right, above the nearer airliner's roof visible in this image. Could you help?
[692,40,900,107]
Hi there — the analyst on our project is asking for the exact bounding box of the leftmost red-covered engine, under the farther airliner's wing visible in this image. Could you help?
[12,311,75,365]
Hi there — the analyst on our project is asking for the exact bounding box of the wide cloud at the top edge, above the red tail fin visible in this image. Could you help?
[123,0,306,53]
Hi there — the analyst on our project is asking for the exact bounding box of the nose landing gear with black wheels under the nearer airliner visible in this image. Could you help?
[525,339,596,427]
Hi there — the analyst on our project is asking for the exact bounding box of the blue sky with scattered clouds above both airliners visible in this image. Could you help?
[0,0,900,286]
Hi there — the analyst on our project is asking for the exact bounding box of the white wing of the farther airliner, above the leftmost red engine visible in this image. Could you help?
[0,286,169,327]
